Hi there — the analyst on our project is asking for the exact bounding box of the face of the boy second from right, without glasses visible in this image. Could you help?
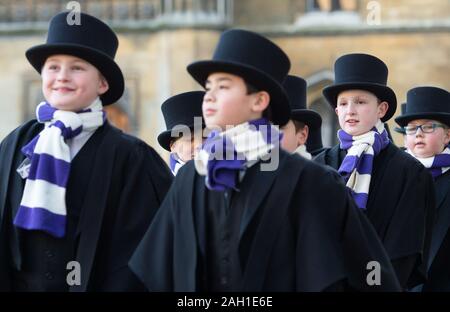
[335,90,388,136]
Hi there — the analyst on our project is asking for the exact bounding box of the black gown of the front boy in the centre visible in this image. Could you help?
[130,151,400,292]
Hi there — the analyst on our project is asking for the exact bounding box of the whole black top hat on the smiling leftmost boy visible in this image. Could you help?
[26,12,124,105]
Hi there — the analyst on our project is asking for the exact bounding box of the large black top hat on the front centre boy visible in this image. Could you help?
[187,29,291,126]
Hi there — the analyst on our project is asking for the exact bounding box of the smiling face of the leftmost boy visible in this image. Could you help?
[41,55,108,112]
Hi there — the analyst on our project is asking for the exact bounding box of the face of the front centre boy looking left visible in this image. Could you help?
[202,73,270,130]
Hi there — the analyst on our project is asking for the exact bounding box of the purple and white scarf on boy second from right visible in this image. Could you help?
[338,120,389,209]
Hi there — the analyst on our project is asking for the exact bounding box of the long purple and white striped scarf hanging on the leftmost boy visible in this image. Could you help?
[14,99,105,237]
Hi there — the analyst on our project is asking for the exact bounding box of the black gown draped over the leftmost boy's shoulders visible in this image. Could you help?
[0,120,172,291]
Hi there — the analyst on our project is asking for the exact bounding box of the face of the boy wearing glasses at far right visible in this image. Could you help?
[405,119,450,158]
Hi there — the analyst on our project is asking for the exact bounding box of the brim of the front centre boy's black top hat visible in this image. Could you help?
[187,61,290,126]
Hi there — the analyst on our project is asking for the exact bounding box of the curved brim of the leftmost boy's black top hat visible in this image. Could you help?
[25,43,125,105]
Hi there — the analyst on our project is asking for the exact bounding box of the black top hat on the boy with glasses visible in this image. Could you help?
[395,87,450,127]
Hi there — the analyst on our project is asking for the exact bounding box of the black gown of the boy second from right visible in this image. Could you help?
[314,143,435,289]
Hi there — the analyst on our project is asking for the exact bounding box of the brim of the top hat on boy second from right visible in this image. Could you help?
[323,82,397,122]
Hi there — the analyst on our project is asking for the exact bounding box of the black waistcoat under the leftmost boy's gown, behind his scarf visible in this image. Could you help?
[8,129,101,292]
